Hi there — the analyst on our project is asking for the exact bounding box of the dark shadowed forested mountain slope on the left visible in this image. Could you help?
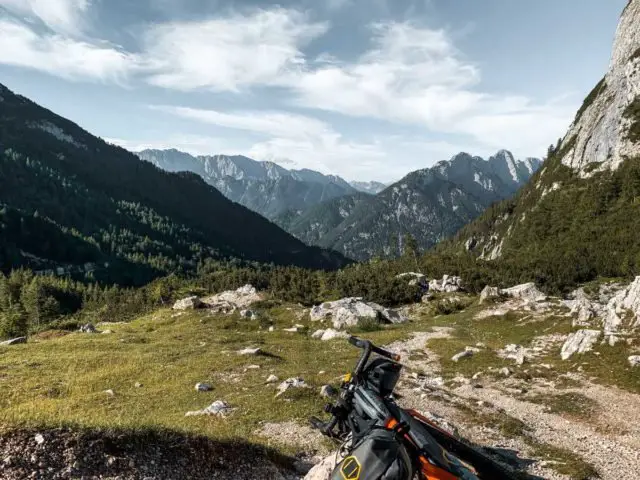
[0,85,346,284]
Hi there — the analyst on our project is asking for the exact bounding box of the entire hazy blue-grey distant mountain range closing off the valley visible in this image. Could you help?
[137,150,541,260]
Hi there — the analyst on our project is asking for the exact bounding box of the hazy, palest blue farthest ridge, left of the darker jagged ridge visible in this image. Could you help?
[137,150,357,219]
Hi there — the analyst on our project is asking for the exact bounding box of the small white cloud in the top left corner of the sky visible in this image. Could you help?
[0,0,90,32]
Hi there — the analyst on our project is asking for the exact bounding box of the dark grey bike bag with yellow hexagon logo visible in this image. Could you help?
[331,429,413,480]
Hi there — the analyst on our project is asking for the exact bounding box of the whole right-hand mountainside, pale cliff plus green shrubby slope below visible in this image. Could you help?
[442,0,640,289]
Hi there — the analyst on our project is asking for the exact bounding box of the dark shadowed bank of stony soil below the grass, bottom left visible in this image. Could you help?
[0,428,298,480]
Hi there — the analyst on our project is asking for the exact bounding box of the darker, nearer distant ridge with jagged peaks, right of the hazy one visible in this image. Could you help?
[276,150,542,260]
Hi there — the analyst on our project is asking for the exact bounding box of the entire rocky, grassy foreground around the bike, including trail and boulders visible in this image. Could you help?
[0,277,640,480]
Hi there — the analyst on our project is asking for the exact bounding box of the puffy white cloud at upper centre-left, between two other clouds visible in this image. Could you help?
[145,8,327,91]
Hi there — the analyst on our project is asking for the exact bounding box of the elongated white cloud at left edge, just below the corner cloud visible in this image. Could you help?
[0,19,135,82]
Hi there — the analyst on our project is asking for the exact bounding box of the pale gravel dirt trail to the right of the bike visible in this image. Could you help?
[388,329,640,480]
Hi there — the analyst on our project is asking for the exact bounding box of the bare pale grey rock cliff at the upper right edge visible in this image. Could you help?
[561,0,640,177]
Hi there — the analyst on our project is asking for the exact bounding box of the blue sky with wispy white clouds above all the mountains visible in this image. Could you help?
[0,0,627,182]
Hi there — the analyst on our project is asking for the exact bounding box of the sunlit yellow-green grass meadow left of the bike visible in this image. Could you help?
[0,305,430,453]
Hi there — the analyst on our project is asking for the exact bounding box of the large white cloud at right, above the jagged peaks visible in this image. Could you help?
[281,23,571,155]
